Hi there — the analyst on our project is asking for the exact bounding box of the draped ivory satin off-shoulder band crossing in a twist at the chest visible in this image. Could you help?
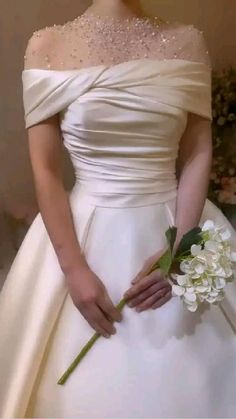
[22,58,212,128]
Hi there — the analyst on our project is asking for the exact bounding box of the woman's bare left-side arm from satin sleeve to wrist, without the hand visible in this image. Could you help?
[28,115,86,273]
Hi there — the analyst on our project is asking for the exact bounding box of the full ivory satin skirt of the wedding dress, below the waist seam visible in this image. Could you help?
[0,185,236,419]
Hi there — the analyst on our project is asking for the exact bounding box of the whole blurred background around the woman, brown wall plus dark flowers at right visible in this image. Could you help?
[0,0,236,288]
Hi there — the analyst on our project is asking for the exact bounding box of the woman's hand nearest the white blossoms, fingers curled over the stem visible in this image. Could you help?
[124,250,172,312]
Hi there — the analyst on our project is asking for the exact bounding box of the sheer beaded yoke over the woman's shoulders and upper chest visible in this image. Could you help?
[25,13,211,70]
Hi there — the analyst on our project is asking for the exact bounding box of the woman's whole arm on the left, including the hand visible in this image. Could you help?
[23,33,121,337]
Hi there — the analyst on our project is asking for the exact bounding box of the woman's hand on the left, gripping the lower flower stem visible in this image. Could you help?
[66,264,122,338]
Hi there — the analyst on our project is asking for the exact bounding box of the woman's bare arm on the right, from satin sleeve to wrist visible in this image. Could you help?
[174,113,212,250]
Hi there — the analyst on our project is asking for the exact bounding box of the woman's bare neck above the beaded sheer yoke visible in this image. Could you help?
[86,0,145,18]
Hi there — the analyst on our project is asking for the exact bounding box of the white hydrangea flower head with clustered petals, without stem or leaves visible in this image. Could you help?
[172,220,236,312]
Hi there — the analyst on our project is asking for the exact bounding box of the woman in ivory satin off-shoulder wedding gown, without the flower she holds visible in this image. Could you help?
[0,0,236,418]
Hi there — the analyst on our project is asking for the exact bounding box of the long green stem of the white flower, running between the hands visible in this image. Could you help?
[57,262,166,385]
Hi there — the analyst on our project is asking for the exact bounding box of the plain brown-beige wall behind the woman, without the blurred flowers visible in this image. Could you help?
[0,0,236,223]
